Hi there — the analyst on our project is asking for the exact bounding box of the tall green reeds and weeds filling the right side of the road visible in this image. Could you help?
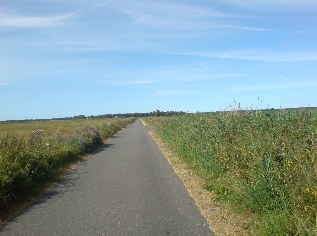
[145,109,317,236]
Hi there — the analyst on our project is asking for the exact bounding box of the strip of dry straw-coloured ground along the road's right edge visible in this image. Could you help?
[146,129,252,236]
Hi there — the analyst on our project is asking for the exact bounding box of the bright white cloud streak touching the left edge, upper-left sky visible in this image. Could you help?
[0,12,78,28]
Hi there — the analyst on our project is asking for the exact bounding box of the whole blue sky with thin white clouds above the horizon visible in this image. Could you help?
[0,0,317,120]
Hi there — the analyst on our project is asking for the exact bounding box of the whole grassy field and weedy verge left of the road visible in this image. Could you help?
[0,118,133,220]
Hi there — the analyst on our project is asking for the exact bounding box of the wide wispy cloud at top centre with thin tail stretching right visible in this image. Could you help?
[89,1,280,32]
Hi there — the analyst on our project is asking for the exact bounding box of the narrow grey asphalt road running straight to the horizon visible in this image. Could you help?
[0,120,213,236]
